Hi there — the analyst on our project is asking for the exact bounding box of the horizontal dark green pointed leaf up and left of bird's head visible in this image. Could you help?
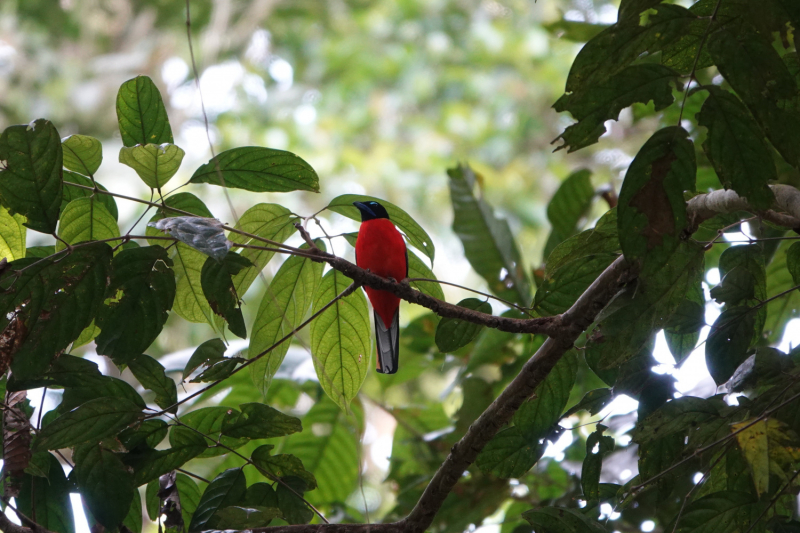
[190,146,319,192]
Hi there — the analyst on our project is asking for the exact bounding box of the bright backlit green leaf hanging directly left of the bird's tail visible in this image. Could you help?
[311,270,372,411]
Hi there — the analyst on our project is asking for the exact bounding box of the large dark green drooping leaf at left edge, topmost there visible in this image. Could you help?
[0,119,62,233]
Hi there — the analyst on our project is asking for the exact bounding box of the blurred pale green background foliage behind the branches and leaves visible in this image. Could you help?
[0,0,748,533]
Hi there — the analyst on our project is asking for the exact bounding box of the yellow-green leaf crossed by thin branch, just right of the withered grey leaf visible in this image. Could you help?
[228,204,298,296]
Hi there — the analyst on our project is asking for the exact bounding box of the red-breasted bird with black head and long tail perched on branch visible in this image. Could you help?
[353,202,408,374]
